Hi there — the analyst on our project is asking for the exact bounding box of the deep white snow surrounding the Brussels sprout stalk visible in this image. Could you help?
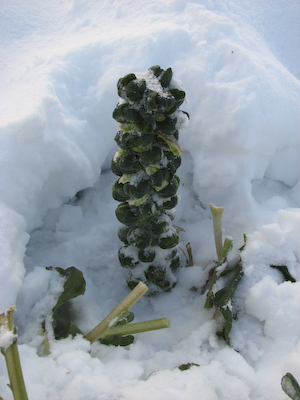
[0,0,300,400]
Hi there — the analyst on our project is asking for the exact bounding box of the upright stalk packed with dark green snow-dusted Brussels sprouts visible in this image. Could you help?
[111,65,186,293]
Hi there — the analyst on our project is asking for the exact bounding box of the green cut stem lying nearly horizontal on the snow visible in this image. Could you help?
[101,318,170,338]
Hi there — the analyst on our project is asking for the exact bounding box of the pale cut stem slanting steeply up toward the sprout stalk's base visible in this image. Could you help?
[85,282,148,343]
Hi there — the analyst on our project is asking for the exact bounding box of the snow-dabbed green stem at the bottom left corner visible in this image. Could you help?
[0,306,28,400]
